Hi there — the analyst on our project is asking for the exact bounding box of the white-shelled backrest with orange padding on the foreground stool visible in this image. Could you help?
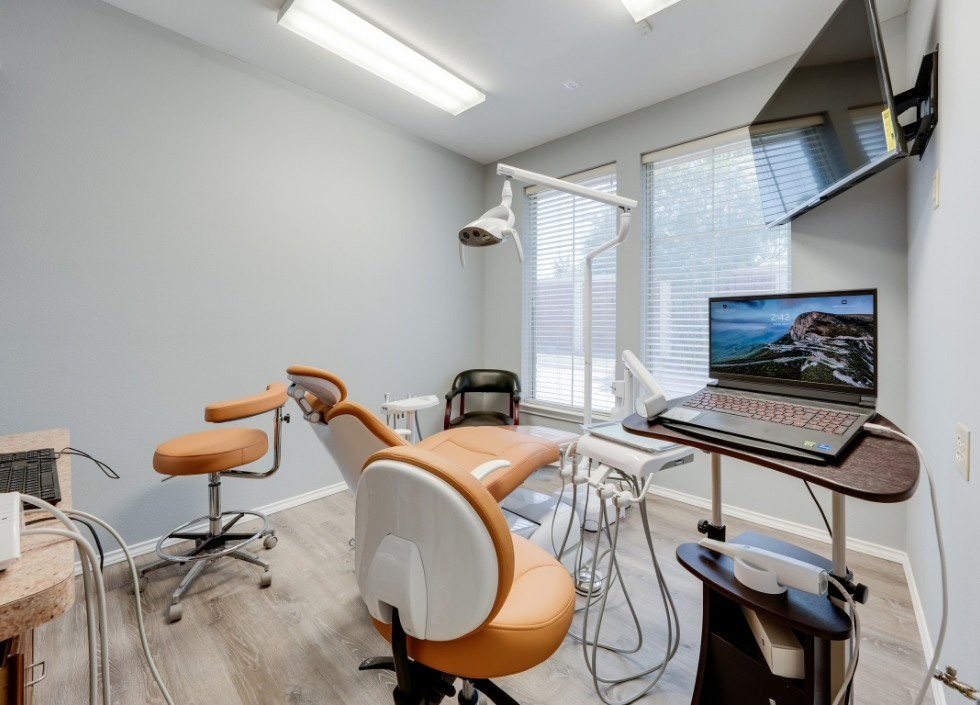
[354,446,514,641]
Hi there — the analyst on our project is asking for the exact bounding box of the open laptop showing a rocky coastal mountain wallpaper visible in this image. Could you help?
[658,289,878,463]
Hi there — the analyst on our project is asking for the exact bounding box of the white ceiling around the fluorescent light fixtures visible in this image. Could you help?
[105,0,909,163]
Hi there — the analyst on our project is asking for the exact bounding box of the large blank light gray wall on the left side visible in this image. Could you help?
[0,0,483,541]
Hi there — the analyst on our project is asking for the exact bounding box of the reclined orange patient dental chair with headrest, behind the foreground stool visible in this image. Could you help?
[286,365,580,567]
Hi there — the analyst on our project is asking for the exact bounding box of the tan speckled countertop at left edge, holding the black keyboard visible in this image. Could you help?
[0,428,75,640]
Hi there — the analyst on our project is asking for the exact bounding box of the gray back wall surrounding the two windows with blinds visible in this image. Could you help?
[478,16,907,548]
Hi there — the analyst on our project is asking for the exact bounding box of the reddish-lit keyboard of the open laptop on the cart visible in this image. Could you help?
[684,389,861,436]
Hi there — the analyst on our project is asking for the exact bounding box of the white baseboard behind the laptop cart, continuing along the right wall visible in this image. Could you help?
[650,486,946,705]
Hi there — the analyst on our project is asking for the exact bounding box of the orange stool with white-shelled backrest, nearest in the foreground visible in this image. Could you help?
[354,446,575,705]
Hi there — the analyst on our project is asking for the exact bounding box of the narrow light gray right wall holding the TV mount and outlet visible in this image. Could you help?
[906,0,980,688]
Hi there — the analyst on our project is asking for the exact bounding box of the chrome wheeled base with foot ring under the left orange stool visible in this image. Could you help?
[137,474,279,622]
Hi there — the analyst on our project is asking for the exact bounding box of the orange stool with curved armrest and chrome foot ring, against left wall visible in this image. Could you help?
[138,383,289,622]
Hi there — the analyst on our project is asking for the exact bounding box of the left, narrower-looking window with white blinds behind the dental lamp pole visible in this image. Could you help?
[523,164,618,413]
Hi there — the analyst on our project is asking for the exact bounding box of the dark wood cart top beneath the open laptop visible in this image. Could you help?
[623,414,919,502]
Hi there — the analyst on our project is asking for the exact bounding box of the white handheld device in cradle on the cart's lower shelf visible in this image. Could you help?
[698,539,828,595]
